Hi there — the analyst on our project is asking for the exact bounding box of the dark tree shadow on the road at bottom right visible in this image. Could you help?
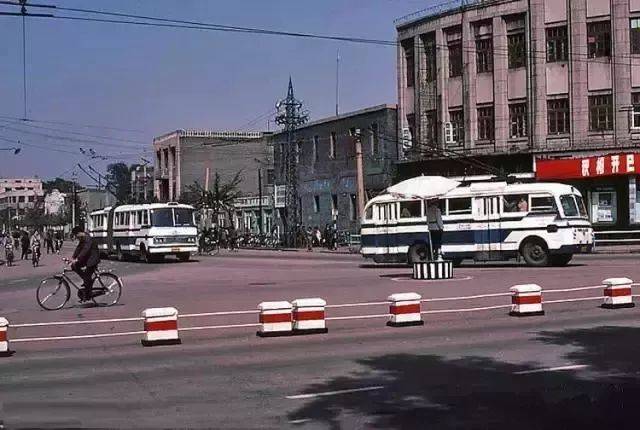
[289,327,640,429]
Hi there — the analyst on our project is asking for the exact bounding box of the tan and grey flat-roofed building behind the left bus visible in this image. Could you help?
[153,130,272,201]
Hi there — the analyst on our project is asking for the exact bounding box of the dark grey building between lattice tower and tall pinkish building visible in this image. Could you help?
[272,104,398,232]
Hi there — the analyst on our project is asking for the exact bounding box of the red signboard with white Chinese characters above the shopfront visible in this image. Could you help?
[536,154,640,179]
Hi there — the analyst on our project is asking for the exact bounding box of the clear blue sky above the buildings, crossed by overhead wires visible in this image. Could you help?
[0,0,442,183]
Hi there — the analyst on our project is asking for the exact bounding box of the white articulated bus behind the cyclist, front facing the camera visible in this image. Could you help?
[88,203,198,262]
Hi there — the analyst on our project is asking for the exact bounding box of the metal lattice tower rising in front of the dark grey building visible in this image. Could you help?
[276,77,309,246]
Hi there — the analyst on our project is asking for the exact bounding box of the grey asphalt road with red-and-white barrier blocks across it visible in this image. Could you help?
[0,251,640,429]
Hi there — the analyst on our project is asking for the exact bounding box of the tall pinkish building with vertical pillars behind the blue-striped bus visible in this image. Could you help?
[396,0,640,232]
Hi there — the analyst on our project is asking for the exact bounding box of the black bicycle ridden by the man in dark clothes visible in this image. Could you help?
[36,259,122,311]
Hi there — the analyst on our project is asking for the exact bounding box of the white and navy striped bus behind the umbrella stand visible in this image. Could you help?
[360,182,593,266]
